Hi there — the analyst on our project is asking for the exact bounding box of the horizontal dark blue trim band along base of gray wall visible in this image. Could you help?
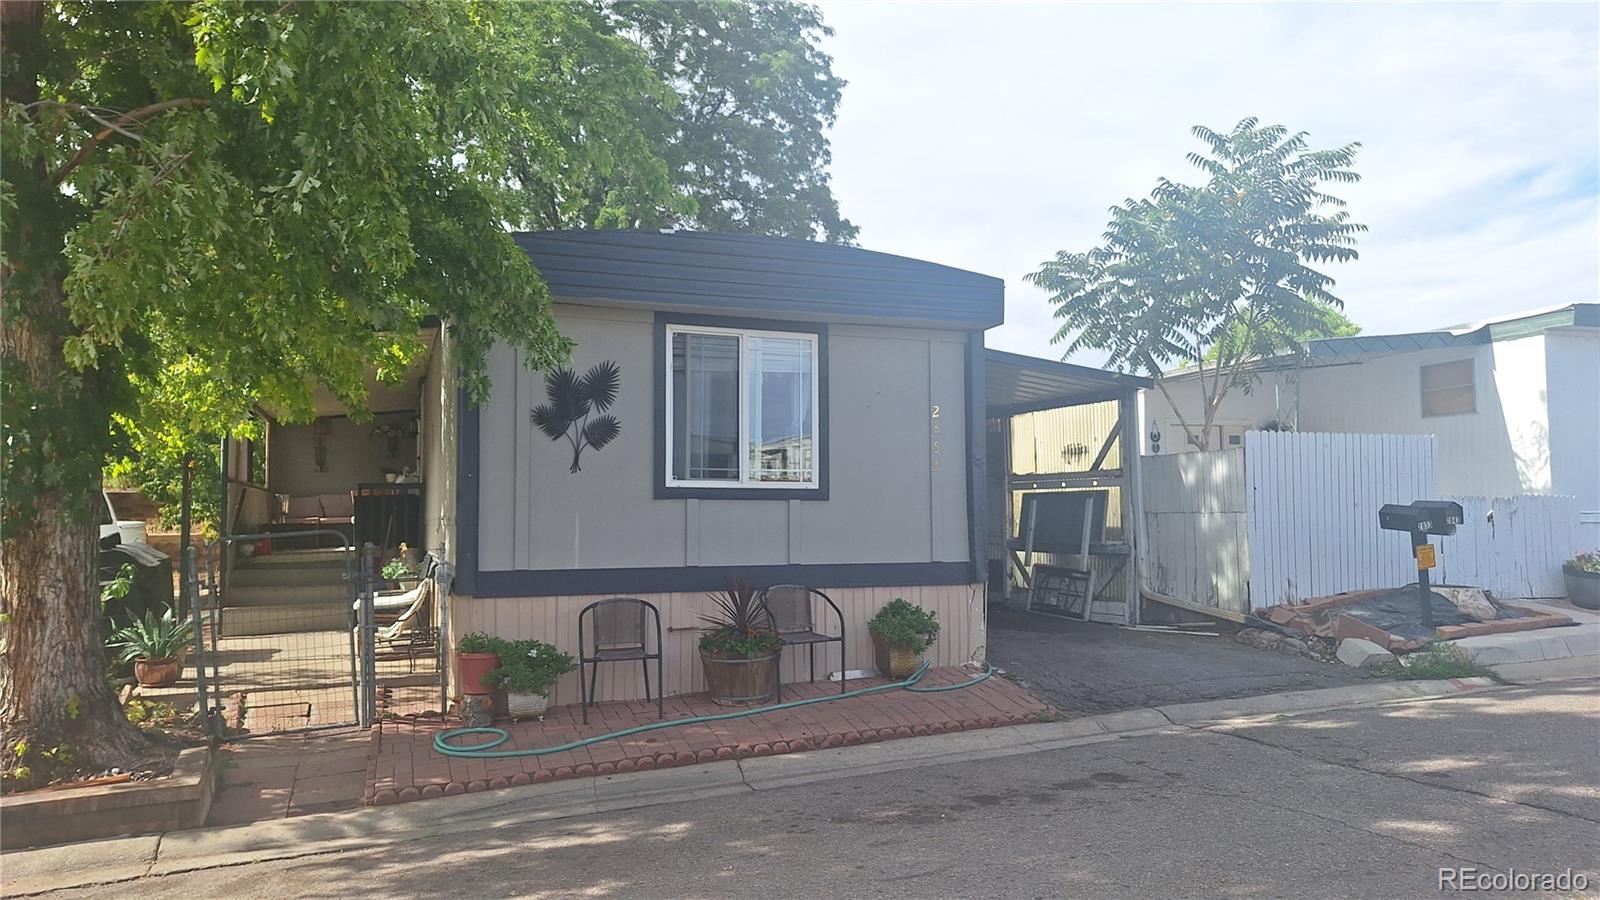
[472,562,976,597]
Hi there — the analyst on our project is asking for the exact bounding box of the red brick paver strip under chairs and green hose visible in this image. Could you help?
[365,668,1050,806]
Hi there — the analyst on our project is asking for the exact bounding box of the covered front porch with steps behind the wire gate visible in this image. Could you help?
[193,325,456,735]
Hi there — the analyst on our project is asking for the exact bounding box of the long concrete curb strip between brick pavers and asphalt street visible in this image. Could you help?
[0,679,1516,897]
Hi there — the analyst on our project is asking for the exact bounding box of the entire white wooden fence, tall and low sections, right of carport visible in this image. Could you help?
[1141,432,1581,613]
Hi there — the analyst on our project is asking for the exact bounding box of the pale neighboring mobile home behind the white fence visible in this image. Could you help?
[1146,303,1600,546]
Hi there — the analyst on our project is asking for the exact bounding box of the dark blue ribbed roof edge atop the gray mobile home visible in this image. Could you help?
[512,229,1005,328]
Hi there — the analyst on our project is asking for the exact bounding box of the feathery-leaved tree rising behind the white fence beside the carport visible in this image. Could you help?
[1026,119,1366,448]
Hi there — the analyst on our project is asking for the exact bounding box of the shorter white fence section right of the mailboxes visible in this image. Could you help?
[1438,495,1581,597]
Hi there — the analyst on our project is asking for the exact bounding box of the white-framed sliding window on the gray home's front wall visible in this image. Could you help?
[662,323,821,490]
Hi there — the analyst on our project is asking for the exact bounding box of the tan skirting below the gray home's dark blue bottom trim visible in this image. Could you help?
[450,585,986,705]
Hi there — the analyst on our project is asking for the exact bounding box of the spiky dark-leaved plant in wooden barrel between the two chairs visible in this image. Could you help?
[699,578,784,706]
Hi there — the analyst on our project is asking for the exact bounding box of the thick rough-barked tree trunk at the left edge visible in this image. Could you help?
[0,0,163,790]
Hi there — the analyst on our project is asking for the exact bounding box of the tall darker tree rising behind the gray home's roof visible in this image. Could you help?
[530,0,859,243]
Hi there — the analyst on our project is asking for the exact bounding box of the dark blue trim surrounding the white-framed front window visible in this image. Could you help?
[651,312,832,500]
